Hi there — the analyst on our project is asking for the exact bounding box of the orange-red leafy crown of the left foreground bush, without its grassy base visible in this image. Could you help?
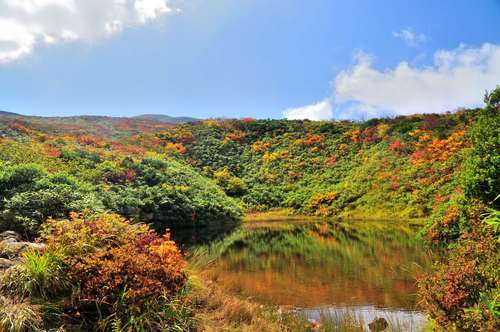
[44,214,186,305]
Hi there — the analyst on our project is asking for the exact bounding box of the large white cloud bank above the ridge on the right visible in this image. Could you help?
[283,43,500,120]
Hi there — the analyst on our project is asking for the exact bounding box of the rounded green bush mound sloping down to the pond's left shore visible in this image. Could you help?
[101,158,242,231]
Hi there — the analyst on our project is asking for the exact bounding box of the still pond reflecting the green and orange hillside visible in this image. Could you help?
[174,220,432,331]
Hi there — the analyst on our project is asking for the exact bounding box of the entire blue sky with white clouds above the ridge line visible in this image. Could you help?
[0,0,500,119]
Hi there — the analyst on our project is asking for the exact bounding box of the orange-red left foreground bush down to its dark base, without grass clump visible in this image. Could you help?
[6,213,187,329]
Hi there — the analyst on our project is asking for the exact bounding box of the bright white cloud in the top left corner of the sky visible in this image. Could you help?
[0,0,171,63]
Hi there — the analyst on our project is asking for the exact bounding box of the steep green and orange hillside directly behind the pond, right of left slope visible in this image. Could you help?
[158,110,477,218]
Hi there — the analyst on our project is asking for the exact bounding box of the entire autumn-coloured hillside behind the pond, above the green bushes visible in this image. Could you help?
[1,110,477,226]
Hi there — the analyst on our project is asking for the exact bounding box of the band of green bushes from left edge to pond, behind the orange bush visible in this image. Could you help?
[0,157,242,238]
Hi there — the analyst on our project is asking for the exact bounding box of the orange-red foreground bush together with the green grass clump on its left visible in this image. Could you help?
[2,214,193,331]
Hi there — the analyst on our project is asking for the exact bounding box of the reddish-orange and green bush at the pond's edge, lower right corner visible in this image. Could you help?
[419,206,500,331]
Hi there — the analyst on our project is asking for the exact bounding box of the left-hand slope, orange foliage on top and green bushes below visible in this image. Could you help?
[0,118,241,238]
